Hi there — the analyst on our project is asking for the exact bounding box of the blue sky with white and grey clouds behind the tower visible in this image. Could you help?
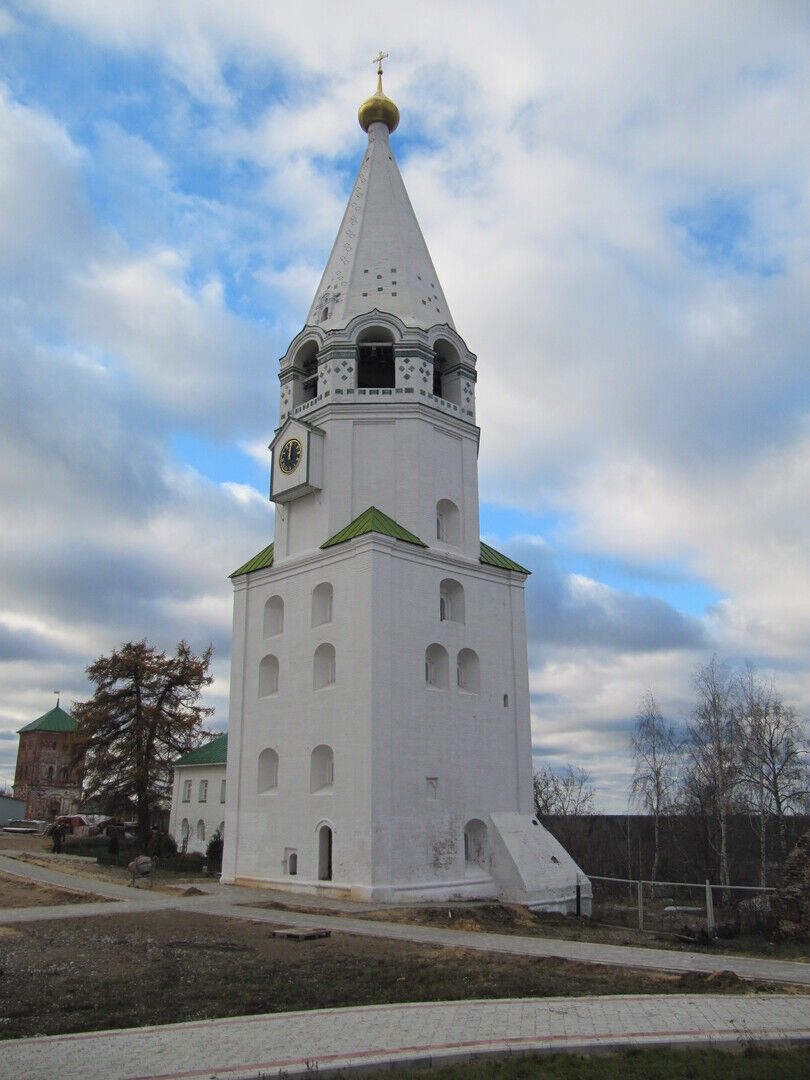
[0,0,810,811]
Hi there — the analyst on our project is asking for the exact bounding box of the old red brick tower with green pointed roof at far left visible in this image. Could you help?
[14,701,81,821]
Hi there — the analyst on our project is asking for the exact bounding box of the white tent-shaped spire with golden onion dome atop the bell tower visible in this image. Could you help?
[307,71,455,330]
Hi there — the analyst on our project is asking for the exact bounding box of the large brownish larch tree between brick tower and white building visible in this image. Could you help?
[73,640,213,840]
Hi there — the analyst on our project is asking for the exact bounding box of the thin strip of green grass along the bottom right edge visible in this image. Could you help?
[354,1047,810,1080]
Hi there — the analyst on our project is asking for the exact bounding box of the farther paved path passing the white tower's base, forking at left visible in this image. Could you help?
[0,855,810,986]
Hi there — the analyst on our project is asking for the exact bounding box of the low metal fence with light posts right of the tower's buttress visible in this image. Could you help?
[589,876,774,937]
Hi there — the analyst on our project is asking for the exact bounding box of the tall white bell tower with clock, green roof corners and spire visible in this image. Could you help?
[222,65,590,910]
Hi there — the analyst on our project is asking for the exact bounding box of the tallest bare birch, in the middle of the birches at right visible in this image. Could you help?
[685,656,742,885]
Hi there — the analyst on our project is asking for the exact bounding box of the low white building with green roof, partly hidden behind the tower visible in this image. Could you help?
[168,735,228,853]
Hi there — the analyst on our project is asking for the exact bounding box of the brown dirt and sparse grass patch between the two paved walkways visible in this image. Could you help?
[0,910,803,1039]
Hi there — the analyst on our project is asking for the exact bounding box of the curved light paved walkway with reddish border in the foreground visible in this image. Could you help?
[0,995,810,1080]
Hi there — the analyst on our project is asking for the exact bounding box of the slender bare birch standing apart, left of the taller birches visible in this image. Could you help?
[630,690,678,881]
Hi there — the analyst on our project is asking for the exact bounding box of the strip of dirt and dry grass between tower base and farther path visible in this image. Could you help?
[246,901,810,961]
